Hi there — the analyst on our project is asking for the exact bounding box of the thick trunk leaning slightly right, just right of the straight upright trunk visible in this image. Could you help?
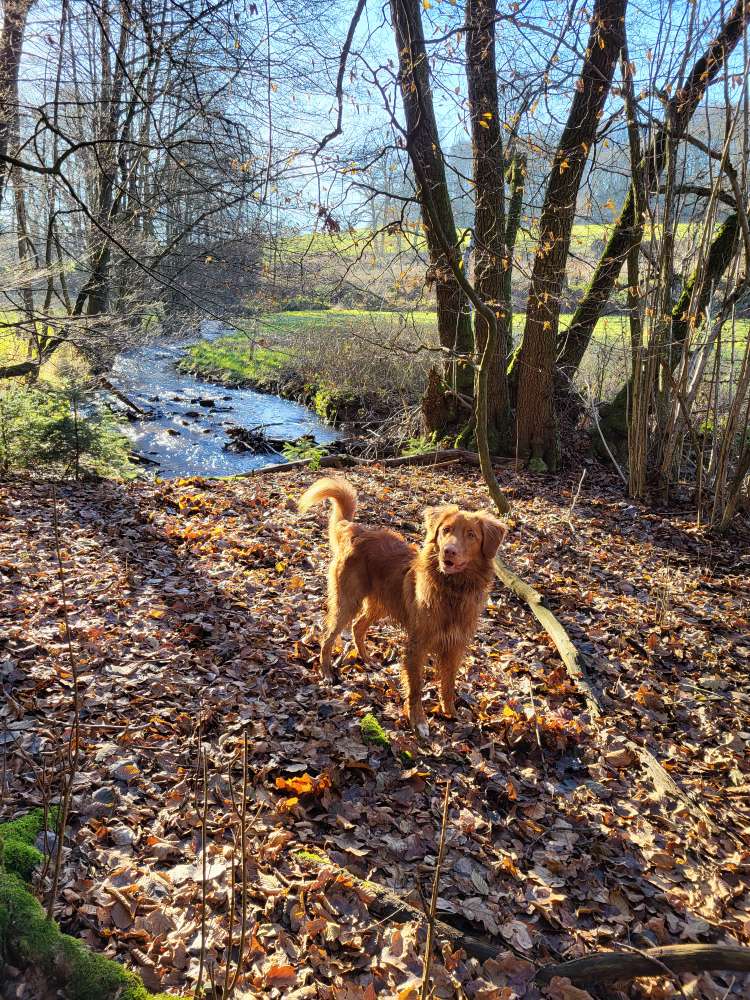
[515,0,627,469]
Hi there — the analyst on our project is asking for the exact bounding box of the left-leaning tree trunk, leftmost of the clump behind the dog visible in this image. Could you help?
[391,0,474,433]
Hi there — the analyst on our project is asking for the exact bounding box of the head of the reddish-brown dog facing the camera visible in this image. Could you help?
[424,504,506,576]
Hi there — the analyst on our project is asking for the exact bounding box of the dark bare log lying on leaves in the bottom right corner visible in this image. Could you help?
[536,944,750,985]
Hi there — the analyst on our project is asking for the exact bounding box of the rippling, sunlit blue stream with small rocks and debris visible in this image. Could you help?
[111,322,337,478]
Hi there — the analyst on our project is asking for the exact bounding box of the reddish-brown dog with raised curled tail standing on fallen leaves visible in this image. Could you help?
[299,478,505,738]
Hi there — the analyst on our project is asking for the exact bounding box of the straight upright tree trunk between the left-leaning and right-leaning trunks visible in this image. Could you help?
[466,0,515,452]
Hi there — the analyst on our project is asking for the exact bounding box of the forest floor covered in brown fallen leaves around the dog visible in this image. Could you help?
[0,467,750,1000]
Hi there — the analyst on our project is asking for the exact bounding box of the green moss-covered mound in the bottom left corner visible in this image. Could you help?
[0,808,168,1000]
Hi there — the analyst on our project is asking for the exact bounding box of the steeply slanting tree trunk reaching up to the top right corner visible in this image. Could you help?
[558,0,750,377]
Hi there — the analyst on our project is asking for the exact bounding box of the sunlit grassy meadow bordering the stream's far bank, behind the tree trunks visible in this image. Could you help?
[181,309,750,419]
